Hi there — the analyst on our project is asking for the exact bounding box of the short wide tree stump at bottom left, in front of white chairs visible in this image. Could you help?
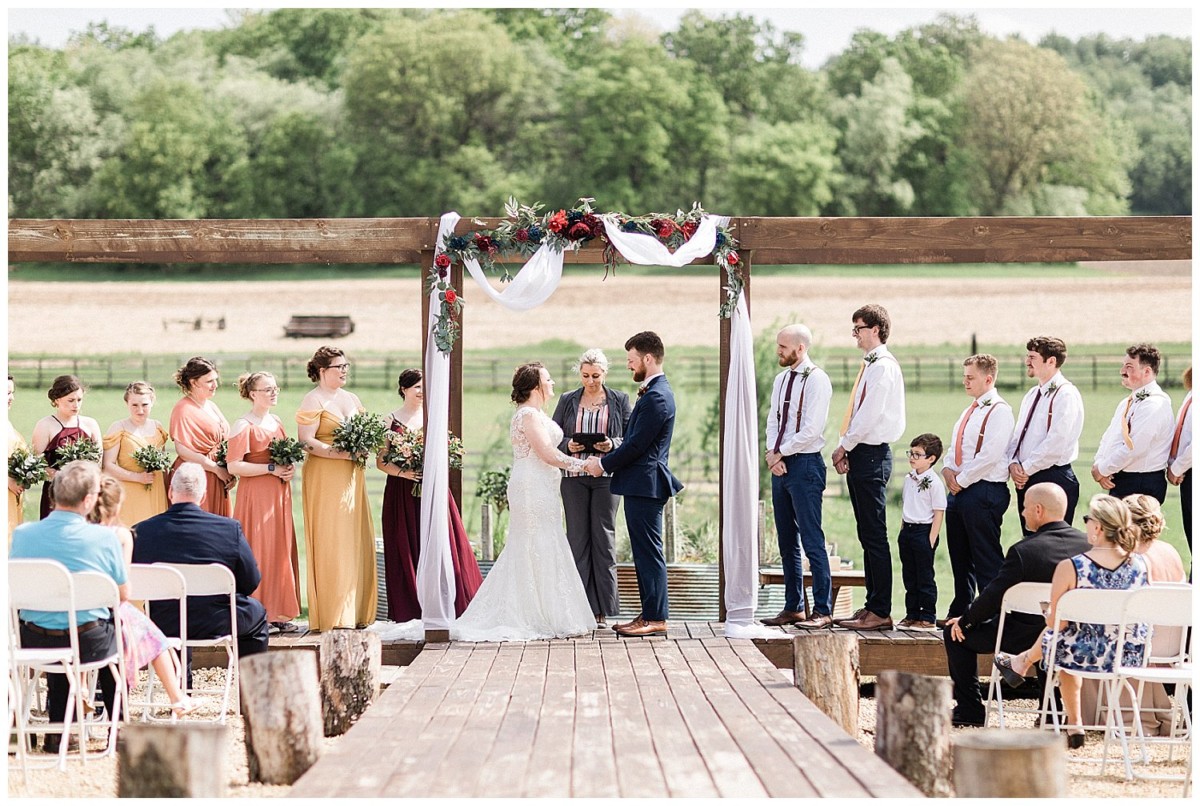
[118,722,229,798]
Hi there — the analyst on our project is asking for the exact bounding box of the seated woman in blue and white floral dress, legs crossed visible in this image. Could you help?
[995,494,1150,748]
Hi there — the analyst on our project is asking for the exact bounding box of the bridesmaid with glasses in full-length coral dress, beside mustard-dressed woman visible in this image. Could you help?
[229,372,300,632]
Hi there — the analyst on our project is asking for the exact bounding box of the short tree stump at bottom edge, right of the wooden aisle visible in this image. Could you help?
[954,728,1067,798]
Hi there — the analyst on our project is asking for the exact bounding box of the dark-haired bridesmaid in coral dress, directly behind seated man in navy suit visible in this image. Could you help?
[168,355,238,517]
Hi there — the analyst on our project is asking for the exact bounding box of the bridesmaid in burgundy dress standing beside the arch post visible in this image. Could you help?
[376,369,484,621]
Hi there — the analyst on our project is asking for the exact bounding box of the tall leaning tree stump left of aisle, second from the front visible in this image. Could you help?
[241,650,324,784]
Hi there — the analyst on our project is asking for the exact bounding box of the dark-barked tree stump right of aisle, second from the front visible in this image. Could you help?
[875,669,953,798]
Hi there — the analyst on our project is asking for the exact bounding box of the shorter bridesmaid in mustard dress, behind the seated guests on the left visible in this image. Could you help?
[104,380,170,527]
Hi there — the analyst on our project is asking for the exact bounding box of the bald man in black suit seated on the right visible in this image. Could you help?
[943,482,1091,727]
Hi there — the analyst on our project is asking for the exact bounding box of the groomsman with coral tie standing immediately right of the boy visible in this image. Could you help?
[942,353,1013,619]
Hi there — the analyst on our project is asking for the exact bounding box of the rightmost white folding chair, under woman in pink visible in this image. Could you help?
[1104,584,1194,789]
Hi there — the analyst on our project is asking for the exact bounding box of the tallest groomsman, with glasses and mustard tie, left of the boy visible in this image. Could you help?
[830,305,905,630]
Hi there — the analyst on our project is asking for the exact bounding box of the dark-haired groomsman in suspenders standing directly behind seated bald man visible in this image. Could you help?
[1008,336,1084,536]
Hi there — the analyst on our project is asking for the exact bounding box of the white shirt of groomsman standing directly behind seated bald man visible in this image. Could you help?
[1008,372,1084,476]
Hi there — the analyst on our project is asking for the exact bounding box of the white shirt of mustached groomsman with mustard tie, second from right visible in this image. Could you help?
[1094,380,1175,476]
